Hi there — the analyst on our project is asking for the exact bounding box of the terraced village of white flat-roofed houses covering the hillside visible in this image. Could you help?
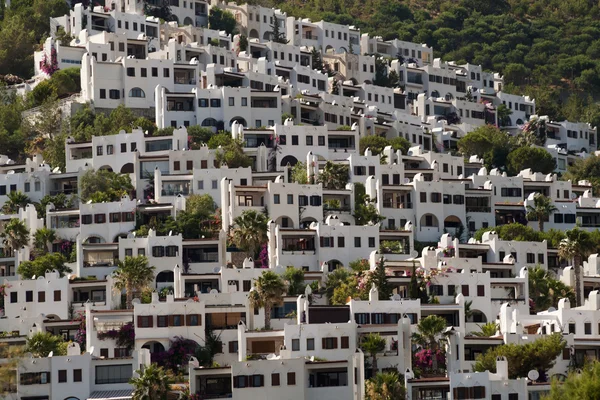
[0,0,600,400]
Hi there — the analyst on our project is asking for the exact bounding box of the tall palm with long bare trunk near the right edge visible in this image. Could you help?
[558,228,594,306]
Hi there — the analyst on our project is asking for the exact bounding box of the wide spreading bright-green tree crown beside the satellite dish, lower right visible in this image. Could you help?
[473,334,566,379]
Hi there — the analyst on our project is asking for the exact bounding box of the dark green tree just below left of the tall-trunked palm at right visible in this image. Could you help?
[528,266,576,313]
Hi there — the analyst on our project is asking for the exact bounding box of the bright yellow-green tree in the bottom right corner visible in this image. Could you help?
[543,361,600,400]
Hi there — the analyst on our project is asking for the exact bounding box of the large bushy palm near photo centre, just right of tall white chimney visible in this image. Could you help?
[233,210,267,258]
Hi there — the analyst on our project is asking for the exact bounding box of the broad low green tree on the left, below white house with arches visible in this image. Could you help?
[79,169,133,203]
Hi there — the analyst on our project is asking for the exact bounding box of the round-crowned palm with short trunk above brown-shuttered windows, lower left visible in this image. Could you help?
[113,256,155,309]
